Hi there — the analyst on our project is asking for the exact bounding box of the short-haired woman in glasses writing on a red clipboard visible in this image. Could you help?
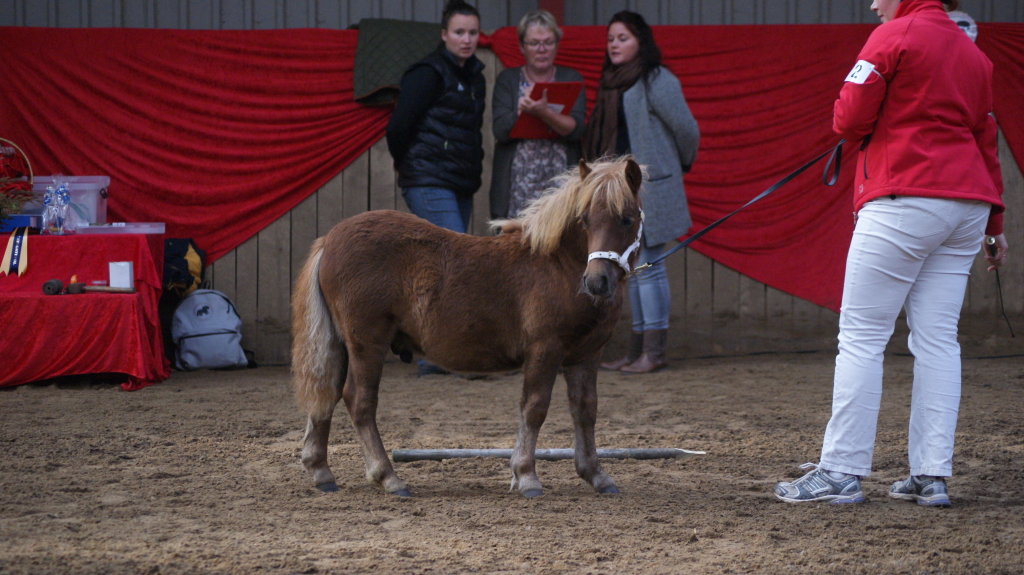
[490,10,587,219]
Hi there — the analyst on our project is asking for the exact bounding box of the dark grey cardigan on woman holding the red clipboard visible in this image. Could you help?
[490,65,587,219]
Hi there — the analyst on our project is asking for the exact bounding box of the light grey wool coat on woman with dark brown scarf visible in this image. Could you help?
[623,67,700,247]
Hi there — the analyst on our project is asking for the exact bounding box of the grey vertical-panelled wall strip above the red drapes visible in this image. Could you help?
[0,0,1024,30]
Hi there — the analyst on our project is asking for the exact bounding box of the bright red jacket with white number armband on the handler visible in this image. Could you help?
[833,0,1004,235]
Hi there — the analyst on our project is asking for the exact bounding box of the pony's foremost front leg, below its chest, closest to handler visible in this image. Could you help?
[563,354,618,493]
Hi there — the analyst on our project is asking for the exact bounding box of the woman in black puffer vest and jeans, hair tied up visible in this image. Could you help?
[387,0,486,233]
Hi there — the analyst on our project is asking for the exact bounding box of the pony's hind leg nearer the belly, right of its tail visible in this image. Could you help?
[341,346,412,497]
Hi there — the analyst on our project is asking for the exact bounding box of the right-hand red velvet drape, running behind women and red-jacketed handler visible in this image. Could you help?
[490,24,1024,311]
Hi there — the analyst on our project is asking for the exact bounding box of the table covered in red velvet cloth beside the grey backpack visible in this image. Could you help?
[0,233,170,391]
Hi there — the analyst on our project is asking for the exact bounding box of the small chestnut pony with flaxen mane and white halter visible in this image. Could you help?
[292,159,643,497]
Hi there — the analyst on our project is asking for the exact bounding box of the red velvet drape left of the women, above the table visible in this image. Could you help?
[0,28,390,261]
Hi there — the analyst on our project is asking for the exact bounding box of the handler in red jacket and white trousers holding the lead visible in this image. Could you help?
[774,0,1007,506]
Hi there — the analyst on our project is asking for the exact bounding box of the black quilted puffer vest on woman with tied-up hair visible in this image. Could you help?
[398,44,486,195]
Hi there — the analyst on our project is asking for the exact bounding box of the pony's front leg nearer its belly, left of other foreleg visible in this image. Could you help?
[511,352,561,497]
